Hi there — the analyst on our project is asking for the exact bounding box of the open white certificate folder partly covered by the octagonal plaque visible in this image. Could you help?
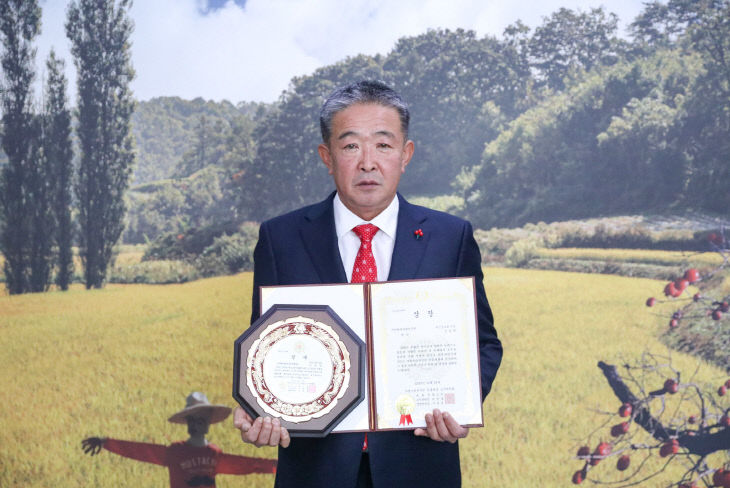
[261,277,484,432]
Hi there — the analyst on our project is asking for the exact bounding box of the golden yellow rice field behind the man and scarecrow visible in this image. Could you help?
[0,268,725,488]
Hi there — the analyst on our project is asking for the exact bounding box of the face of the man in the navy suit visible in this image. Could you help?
[318,103,414,220]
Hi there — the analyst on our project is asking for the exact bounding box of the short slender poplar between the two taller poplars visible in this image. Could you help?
[43,50,74,290]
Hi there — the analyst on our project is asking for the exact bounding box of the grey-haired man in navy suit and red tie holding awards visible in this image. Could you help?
[234,81,502,488]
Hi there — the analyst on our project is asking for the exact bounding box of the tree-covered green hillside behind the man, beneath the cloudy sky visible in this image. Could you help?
[127,0,730,239]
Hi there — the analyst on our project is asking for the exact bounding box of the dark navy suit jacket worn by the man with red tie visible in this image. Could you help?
[251,193,502,488]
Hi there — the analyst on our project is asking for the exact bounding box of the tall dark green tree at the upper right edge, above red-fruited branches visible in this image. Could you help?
[631,0,730,212]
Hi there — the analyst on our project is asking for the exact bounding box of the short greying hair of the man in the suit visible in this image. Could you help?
[319,80,411,144]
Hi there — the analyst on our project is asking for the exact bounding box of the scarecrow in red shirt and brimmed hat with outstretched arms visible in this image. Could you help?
[81,391,276,488]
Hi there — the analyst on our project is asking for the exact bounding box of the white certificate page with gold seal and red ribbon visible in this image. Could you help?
[370,278,482,429]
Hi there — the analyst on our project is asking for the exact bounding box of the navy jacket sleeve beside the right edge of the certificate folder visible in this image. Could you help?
[457,222,502,401]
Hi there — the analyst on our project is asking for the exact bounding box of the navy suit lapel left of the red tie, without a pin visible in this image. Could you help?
[300,193,347,283]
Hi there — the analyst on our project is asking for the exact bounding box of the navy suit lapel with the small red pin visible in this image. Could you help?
[388,194,431,280]
